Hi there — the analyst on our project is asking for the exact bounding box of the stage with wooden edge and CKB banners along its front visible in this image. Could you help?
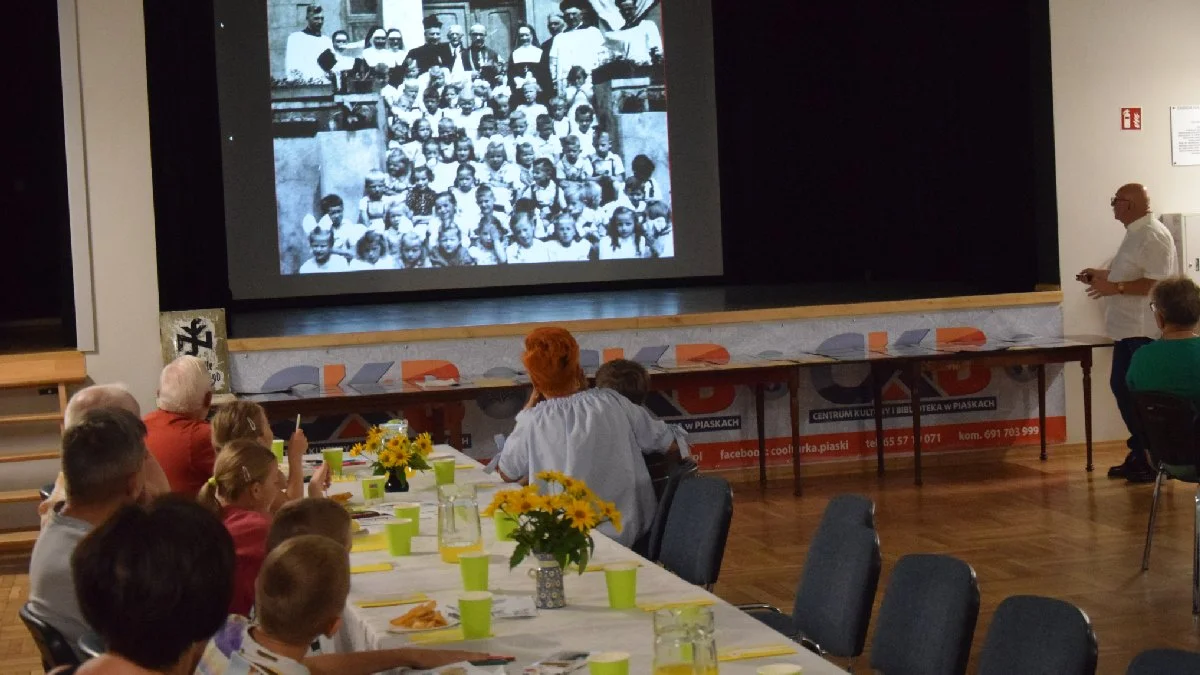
[229,281,1066,470]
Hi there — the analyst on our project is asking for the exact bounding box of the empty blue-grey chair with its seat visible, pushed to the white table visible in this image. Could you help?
[738,495,882,665]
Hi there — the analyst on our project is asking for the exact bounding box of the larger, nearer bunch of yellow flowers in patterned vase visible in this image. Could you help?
[484,471,620,609]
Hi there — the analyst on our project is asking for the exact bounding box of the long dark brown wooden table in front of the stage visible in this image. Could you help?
[242,336,1112,495]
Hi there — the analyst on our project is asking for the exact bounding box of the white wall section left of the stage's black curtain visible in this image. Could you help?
[72,0,162,410]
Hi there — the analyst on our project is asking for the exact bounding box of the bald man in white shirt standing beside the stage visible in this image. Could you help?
[1075,183,1177,483]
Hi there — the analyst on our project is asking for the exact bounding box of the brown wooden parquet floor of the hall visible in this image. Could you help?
[0,446,1200,675]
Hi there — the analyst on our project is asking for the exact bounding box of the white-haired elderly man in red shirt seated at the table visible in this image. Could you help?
[143,357,216,498]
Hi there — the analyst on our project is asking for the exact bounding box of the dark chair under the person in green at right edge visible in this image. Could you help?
[1134,392,1200,614]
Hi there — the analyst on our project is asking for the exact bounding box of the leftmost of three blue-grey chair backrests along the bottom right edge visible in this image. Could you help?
[871,554,979,675]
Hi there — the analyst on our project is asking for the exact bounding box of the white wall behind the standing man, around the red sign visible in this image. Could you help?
[1050,0,1200,441]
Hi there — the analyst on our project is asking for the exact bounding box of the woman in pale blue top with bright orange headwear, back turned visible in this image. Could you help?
[496,328,688,546]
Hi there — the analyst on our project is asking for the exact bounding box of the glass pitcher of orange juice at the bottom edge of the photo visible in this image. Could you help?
[654,607,718,675]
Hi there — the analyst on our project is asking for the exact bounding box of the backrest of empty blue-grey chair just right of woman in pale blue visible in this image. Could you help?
[659,476,733,586]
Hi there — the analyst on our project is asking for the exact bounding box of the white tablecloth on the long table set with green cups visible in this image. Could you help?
[330,446,844,675]
